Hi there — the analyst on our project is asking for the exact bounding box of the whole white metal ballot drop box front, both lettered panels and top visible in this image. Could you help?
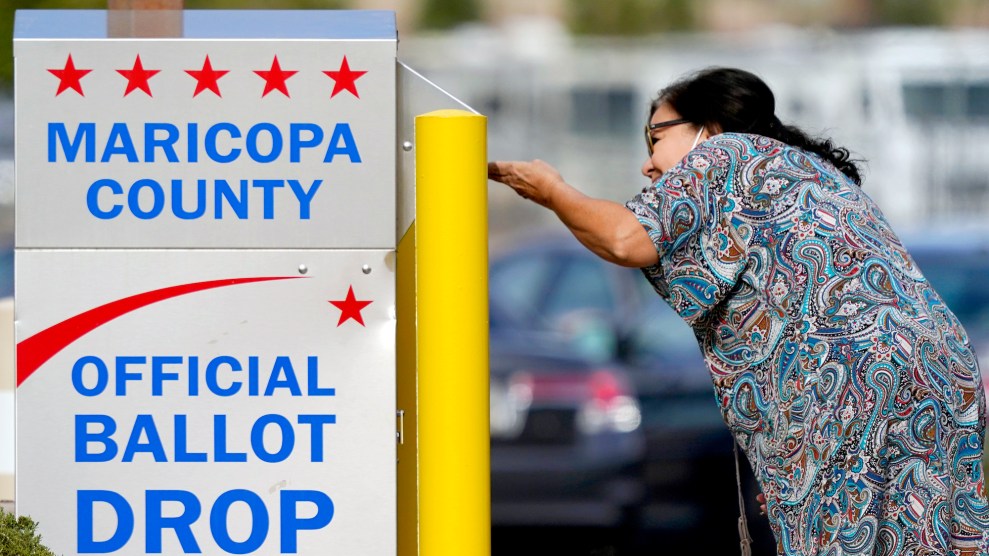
[15,12,396,556]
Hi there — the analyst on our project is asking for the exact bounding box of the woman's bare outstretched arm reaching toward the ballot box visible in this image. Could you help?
[488,160,659,267]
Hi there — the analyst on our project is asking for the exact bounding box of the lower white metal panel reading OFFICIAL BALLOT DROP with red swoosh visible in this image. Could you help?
[17,251,395,554]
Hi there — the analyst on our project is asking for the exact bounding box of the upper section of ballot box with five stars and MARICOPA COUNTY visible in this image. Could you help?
[15,11,396,249]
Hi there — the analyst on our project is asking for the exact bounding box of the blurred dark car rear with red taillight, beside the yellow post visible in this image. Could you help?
[490,303,643,527]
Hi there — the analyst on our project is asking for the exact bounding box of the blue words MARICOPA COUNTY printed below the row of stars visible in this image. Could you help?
[48,122,362,220]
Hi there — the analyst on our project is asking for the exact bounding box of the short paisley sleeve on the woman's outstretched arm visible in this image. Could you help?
[626,135,751,326]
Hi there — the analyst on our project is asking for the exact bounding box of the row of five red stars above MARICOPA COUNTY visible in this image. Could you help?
[48,54,367,98]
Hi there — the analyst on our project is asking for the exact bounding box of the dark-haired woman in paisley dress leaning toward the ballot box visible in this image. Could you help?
[488,69,989,555]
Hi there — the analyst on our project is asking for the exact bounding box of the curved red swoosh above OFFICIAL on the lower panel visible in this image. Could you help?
[17,276,304,386]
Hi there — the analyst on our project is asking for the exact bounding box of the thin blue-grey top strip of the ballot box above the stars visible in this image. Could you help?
[14,10,397,40]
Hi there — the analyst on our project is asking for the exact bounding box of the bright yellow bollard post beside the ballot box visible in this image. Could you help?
[415,110,491,556]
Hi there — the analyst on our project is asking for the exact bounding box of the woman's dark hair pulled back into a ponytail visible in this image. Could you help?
[649,68,862,185]
